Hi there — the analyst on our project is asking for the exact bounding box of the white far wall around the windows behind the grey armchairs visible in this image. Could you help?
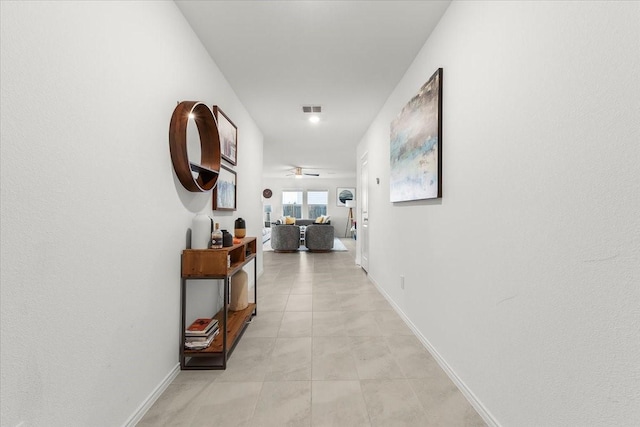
[263,177,358,237]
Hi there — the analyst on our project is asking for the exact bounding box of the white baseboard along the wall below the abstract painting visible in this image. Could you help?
[369,276,500,427]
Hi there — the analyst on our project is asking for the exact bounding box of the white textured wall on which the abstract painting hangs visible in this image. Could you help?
[358,2,640,426]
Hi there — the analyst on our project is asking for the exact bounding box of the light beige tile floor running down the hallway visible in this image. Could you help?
[138,239,486,427]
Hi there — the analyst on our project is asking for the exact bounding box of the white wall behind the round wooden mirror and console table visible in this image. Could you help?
[0,1,262,426]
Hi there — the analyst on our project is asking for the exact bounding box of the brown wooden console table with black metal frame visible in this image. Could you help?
[180,237,258,370]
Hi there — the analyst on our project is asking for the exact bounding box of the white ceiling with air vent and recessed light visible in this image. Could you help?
[176,0,450,179]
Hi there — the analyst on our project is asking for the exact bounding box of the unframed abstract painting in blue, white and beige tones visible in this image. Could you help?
[389,68,442,202]
